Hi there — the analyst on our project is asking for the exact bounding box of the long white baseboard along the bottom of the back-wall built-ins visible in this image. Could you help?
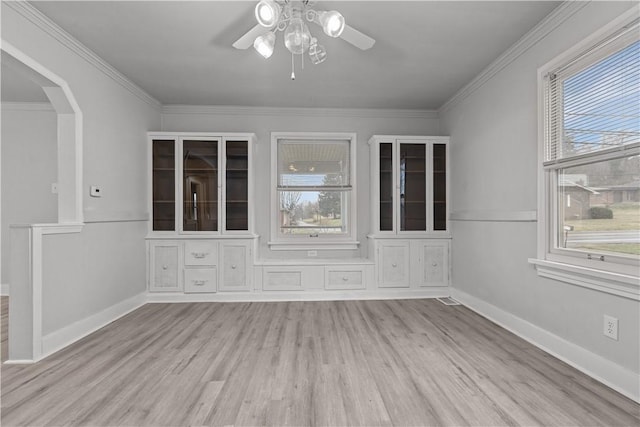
[147,286,450,303]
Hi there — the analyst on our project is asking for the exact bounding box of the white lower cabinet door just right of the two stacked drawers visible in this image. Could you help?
[219,242,252,291]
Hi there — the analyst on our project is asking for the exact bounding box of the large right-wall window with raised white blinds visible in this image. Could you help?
[540,15,640,283]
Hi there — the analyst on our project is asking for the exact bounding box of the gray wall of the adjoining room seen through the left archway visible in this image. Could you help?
[0,104,58,285]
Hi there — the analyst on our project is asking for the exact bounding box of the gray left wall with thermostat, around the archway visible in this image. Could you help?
[2,2,160,335]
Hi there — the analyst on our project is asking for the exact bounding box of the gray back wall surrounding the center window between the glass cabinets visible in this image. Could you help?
[161,107,439,258]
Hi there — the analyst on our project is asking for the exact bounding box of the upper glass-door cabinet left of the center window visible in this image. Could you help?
[149,133,255,234]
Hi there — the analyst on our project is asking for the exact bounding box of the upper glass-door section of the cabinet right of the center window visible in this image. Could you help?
[369,136,448,234]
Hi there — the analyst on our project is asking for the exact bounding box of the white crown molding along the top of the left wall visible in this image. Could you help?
[2,0,162,110]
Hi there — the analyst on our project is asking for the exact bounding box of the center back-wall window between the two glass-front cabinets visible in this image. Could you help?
[271,133,355,249]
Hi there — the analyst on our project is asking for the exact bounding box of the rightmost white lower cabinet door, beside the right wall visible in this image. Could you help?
[414,240,449,286]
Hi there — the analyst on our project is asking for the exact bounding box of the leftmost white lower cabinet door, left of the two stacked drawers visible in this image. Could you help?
[149,242,182,292]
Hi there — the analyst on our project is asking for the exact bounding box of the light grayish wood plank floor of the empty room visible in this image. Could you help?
[2,300,640,426]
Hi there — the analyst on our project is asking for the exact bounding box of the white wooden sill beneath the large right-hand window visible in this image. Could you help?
[529,258,640,301]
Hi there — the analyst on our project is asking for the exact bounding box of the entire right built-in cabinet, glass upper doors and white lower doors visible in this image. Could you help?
[368,135,450,289]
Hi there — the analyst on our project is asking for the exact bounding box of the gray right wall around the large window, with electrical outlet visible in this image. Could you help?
[441,2,640,373]
